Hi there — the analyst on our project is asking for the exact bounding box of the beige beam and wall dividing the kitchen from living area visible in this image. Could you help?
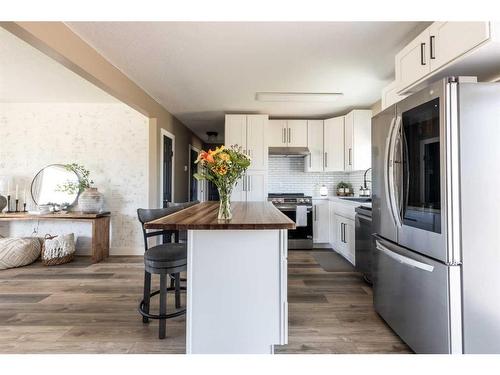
[0,22,202,207]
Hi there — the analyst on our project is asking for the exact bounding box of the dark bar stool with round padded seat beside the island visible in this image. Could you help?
[137,206,187,339]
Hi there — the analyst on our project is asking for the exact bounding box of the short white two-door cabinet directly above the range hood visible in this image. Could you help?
[268,120,307,147]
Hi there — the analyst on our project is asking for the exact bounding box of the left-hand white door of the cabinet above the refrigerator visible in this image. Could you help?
[395,29,431,89]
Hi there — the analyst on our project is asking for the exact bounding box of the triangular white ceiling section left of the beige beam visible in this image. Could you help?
[0,27,117,103]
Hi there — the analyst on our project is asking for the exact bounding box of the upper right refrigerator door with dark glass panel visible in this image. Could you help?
[391,80,451,263]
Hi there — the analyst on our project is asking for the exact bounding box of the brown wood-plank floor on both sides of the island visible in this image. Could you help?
[0,251,411,353]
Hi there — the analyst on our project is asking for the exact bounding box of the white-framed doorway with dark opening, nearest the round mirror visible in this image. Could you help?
[161,129,175,208]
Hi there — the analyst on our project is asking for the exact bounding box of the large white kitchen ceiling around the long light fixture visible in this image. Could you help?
[64,22,427,139]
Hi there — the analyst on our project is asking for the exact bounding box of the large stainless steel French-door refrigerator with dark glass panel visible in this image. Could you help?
[372,77,500,353]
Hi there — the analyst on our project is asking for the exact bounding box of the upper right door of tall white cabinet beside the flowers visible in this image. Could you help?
[247,115,268,170]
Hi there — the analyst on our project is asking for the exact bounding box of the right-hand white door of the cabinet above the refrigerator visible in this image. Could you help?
[429,22,490,70]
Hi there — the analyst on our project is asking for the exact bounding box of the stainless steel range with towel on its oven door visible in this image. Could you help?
[267,193,313,249]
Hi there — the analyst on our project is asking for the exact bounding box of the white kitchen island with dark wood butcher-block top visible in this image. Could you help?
[145,202,295,354]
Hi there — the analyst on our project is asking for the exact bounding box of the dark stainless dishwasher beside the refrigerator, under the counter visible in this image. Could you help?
[355,206,373,284]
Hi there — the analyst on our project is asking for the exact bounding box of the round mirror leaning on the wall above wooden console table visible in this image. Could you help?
[31,164,80,207]
